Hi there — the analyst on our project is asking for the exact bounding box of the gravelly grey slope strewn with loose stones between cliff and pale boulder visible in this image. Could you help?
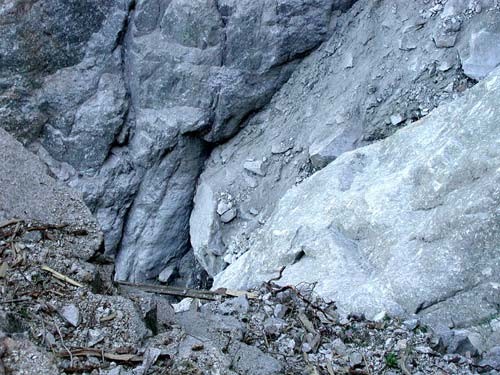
[191,0,500,275]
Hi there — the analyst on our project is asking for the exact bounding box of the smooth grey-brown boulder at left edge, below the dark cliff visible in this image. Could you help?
[0,129,102,259]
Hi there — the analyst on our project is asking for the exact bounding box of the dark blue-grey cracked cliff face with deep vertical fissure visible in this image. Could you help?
[0,0,353,280]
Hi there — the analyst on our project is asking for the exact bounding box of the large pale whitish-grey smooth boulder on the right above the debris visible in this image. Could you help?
[215,64,500,350]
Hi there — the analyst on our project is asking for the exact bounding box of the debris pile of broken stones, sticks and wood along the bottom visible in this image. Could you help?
[0,220,500,375]
